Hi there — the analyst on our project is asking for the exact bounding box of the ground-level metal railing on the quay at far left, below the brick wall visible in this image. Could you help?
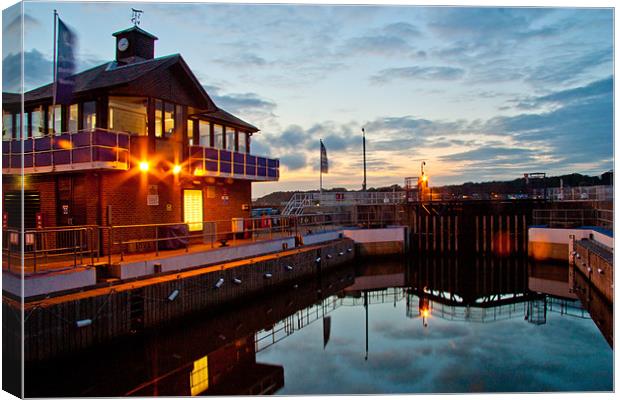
[2,225,100,274]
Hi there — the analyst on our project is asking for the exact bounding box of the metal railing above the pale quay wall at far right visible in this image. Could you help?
[532,209,614,230]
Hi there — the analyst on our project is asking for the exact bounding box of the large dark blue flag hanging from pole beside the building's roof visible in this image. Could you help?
[56,18,77,104]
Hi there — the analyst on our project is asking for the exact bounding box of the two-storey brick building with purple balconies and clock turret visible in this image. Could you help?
[2,26,279,242]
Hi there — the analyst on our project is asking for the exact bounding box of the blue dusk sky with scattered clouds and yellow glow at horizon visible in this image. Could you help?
[3,2,614,197]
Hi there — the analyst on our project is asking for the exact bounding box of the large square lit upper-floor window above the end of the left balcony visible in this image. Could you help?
[108,97,148,135]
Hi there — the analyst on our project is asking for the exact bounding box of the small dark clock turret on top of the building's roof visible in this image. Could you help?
[112,26,157,64]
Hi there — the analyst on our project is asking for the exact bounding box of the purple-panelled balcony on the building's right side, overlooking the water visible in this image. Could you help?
[188,146,280,181]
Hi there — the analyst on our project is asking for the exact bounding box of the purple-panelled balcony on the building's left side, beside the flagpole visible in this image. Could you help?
[2,128,130,174]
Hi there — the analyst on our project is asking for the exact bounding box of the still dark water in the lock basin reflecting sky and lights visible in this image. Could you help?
[25,258,613,397]
